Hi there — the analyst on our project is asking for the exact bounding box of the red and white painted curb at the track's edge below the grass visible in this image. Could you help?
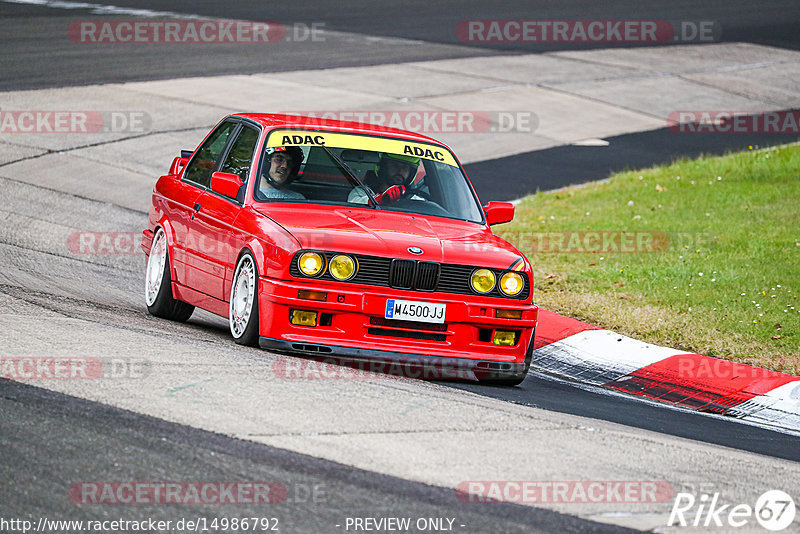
[531,308,800,431]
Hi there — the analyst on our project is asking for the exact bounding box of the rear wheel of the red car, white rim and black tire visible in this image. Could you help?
[144,228,194,323]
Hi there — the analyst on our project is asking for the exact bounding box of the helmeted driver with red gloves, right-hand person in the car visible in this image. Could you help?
[347,152,420,204]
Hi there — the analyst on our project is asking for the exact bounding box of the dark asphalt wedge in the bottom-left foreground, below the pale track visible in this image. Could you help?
[0,381,632,533]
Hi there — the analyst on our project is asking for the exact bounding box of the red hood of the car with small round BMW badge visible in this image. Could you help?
[256,204,520,269]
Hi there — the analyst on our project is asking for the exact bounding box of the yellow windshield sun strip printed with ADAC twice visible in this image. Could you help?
[266,130,458,167]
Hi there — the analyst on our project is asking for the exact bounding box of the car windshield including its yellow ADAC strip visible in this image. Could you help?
[253,134,483,223]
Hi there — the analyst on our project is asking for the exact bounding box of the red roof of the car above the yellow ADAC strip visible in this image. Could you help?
[233,113,450,149]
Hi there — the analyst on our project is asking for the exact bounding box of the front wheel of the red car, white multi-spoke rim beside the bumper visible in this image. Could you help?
[228,250,258,347]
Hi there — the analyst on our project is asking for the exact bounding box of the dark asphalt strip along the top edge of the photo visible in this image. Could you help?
[0,0,800,90]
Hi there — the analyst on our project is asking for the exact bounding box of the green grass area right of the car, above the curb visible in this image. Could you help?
[496,145,800,374]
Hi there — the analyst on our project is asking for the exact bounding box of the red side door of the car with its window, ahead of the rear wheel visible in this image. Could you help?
[191,123,259,300]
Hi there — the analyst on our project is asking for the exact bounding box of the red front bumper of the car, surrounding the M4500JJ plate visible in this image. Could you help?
[259,277,538,371]
